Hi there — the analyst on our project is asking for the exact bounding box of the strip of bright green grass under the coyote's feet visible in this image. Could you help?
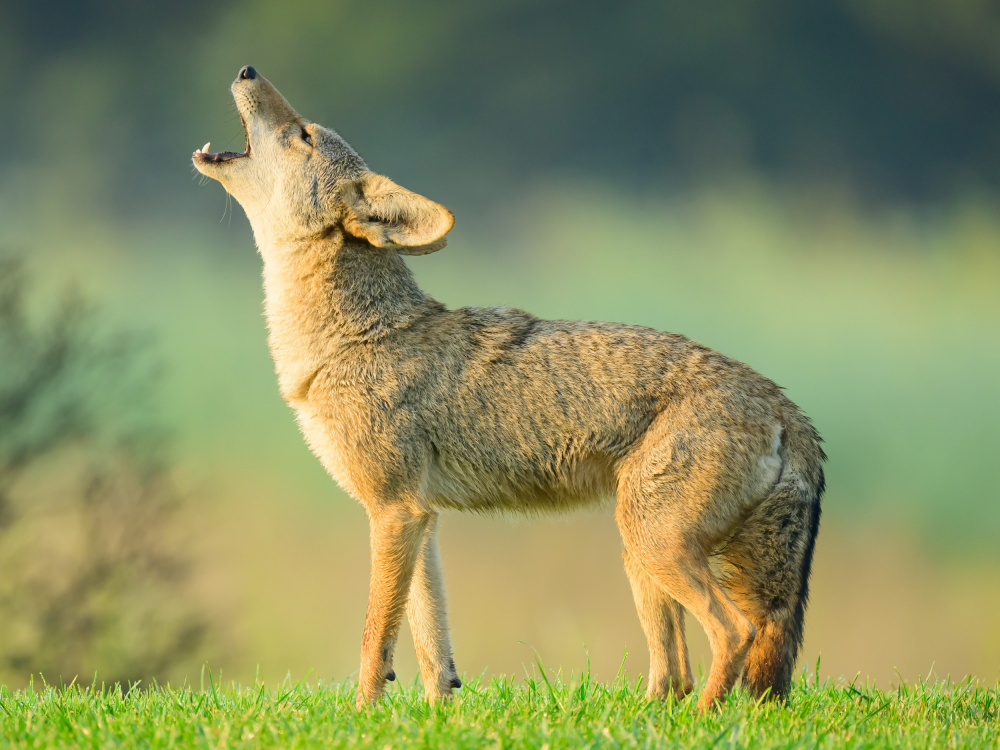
[0,675,1000,749]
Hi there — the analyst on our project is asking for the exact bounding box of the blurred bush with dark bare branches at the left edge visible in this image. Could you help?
[0,258,210,686]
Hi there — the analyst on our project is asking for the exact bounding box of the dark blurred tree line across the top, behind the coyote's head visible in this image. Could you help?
[0,0,1000,223]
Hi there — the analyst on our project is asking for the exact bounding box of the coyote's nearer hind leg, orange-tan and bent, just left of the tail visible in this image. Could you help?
[615,483,757,710]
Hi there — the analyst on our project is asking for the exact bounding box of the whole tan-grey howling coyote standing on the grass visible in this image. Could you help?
[192,66,825,709]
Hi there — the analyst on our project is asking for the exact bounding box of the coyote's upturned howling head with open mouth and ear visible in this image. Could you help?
[192,65,455,255]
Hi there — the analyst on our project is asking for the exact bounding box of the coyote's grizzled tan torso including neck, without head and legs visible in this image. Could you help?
[265,238,802,538]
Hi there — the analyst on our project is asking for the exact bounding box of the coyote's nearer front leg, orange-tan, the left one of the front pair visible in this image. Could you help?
[356,506,430,708]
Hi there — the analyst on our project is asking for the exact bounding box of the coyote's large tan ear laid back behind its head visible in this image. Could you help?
[341,172,455,255]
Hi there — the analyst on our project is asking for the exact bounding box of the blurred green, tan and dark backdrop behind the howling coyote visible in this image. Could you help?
[0,0,1000,685]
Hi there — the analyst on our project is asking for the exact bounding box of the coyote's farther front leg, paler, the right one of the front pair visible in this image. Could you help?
[406,513,462,703]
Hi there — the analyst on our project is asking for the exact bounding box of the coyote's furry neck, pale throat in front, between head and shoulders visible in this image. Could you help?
[261,238,436,401]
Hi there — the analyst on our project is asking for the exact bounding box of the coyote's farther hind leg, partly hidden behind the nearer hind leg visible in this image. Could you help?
[624,549,694,699]
